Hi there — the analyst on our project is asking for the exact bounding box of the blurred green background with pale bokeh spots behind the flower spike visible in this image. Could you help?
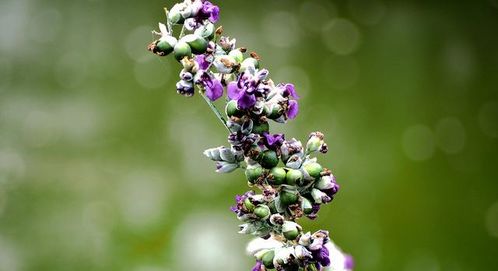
[0,0,498,271]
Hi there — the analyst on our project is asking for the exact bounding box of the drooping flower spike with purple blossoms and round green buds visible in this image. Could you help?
[148,0,352,271]
